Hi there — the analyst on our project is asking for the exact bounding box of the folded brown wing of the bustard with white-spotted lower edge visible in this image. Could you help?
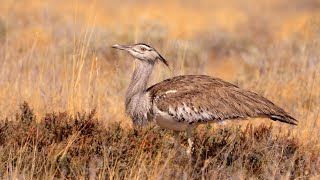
[147,75,297,124]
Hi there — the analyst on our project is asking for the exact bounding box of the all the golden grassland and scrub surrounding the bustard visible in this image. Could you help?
[0,0,320,179]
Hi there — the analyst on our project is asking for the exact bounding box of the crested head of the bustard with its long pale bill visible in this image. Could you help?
[112,43,169,67]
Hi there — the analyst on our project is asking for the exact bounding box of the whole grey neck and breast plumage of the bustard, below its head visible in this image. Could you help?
[125,60,154,125]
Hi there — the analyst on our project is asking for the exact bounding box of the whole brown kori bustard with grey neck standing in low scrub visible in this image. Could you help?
[112,43,297,154]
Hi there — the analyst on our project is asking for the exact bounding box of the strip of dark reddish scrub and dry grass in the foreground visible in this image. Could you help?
[0,103,320,179]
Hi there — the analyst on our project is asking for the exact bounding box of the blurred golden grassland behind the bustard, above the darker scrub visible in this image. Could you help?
[0,0,320,138]
